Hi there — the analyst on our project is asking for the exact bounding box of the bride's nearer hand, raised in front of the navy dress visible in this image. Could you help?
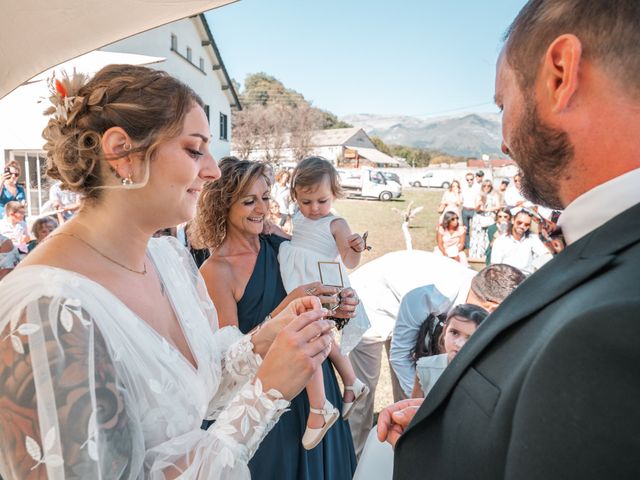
[257,297,334,400]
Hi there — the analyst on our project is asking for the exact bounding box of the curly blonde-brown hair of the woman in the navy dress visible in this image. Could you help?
[189,157,271,250]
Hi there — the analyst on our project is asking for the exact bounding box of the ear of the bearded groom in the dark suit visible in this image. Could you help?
[539,34,582,113]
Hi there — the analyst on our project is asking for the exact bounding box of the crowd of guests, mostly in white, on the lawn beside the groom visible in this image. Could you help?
[435,170,562,274]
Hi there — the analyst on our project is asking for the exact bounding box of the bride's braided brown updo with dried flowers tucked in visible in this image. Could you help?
[42,65,203,200]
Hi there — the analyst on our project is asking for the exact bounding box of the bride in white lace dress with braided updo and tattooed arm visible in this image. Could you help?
[0,65,333,479]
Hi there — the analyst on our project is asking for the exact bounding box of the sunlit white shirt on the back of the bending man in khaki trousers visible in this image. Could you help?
[349,250,475,341]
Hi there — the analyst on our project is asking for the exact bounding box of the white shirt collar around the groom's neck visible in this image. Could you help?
[558,168,640,245]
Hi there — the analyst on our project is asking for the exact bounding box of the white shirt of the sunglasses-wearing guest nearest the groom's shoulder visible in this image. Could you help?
[491,233,552,275]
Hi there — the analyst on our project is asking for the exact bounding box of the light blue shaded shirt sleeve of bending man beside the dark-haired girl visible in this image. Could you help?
[389,262,476,396]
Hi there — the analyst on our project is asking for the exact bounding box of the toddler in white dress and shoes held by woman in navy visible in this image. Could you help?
[278,157,369,450]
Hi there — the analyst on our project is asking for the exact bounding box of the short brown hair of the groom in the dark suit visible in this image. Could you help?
[505,0,640,96]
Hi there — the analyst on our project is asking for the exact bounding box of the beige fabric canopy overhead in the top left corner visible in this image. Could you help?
[0,0,236,98]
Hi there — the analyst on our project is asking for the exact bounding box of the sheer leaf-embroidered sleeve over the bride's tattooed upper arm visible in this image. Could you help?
[0,298,144,479]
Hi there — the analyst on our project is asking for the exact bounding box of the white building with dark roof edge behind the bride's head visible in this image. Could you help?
[0,14,241,215]
